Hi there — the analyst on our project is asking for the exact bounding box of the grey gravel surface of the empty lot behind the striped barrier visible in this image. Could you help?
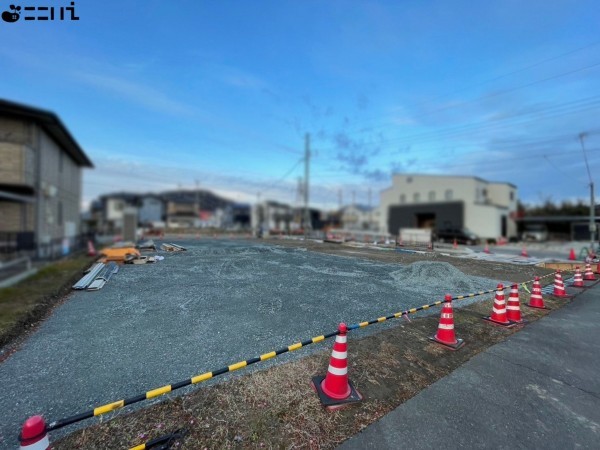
[0,240,497,448]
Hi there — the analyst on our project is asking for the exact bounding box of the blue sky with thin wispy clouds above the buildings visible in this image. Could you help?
[0,0,600,212]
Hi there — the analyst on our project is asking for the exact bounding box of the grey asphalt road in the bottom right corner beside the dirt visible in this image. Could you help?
[339,285,600,450]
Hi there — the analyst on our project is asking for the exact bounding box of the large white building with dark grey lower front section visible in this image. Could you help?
[379,174,517,239]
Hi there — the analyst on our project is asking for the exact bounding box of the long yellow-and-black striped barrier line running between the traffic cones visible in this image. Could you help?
[46,272,556,431]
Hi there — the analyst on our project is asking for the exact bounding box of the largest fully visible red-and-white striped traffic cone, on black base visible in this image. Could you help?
[312,323,362,410]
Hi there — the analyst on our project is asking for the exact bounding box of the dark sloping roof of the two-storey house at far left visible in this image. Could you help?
[0,99,94,168]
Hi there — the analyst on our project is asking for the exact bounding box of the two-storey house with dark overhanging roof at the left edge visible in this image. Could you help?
[0,100,93,258]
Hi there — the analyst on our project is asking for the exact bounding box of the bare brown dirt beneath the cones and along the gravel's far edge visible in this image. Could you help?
[53,240,567,449]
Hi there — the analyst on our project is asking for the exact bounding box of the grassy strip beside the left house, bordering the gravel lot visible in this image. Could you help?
[0,256,91,345]
